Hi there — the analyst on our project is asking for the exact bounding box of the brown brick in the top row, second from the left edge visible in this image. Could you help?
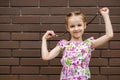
[11,0,38,6]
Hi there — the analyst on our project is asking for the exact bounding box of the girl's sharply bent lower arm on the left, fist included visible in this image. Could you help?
[41,31,61,60]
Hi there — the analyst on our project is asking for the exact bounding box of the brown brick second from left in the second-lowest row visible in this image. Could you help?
[11,66,39,75]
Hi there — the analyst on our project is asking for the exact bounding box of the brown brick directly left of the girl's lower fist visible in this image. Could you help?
[11,33,40,40]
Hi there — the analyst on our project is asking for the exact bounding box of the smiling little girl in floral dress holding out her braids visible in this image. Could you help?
[42,7,113,80]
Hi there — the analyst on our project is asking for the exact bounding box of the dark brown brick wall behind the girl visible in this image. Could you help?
[0,0,120,80]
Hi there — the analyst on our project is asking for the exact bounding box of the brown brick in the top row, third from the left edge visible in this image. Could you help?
[40,0,68,7]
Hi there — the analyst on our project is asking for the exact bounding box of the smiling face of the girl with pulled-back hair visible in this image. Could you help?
[66,16,86,39]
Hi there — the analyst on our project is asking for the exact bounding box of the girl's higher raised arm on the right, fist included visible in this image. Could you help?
[93,7,113,48]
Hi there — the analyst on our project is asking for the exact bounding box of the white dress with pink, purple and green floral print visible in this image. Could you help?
[58,37,94,80]
